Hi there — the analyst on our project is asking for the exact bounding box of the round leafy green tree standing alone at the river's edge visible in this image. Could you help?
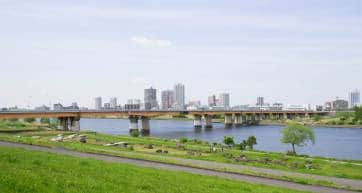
[281,122,315,155]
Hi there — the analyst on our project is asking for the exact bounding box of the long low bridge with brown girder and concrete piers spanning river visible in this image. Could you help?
[0,110,329,134]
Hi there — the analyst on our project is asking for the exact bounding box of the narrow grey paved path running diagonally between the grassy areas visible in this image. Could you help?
[0,141,353,193]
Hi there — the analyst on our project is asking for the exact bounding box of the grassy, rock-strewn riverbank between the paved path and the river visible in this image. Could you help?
[0,121,362,190]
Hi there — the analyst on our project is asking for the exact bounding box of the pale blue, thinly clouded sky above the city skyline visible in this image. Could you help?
[0,0,362,107]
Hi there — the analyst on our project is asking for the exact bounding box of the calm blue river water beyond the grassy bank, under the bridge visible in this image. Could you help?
[80,119,362,160]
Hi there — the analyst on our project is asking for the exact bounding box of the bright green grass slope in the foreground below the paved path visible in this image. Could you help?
[0,147,308,193]
